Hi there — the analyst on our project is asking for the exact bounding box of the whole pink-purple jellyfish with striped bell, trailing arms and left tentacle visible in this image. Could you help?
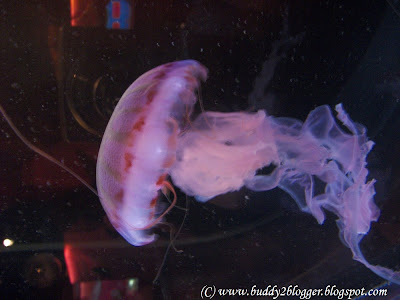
[0,60,400,284]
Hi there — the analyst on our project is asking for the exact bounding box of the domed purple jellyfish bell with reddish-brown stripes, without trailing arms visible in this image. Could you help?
[96,60,207,246]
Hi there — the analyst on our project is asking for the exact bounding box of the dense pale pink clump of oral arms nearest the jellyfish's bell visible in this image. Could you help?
[170,111,279,202]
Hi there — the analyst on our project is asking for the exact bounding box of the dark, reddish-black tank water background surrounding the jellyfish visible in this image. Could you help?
[0,0,400,299]
